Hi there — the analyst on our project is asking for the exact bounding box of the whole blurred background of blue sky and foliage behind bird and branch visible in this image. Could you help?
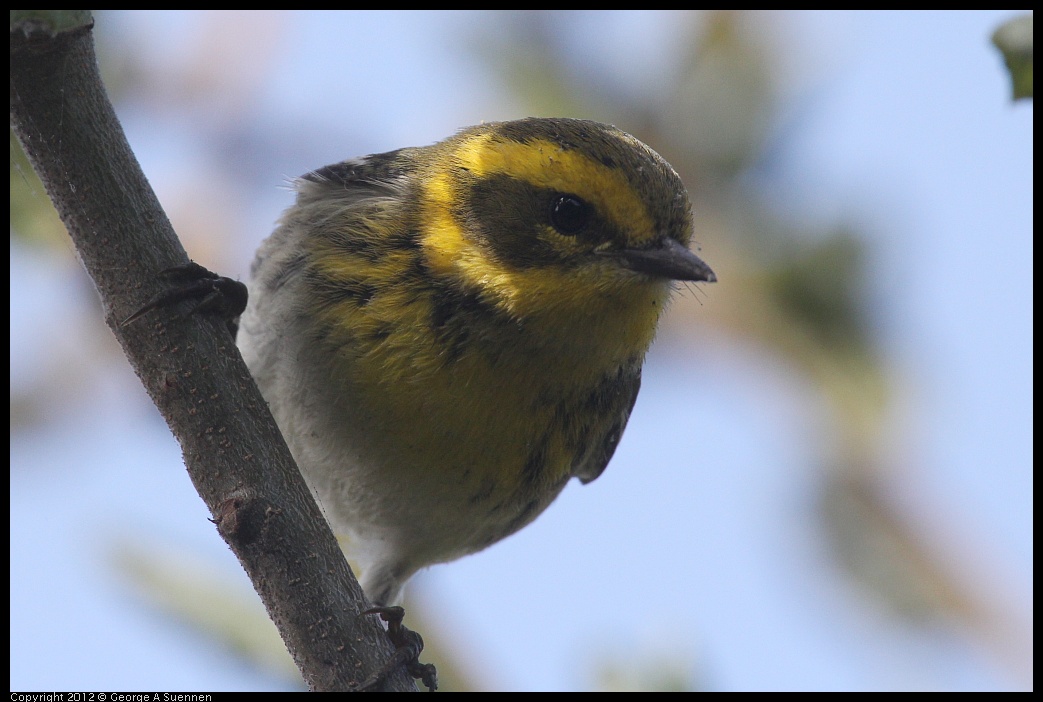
[10,10,1033,691]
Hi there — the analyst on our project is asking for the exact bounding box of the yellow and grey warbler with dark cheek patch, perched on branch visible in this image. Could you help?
[238,119,715,604]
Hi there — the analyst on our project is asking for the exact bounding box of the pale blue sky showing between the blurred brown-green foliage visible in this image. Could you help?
[10,10,1033,692]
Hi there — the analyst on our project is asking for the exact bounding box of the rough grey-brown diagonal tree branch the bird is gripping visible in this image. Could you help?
[10,10,416,691]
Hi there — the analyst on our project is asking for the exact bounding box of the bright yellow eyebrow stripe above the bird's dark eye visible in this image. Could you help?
[455,134,657,246]
